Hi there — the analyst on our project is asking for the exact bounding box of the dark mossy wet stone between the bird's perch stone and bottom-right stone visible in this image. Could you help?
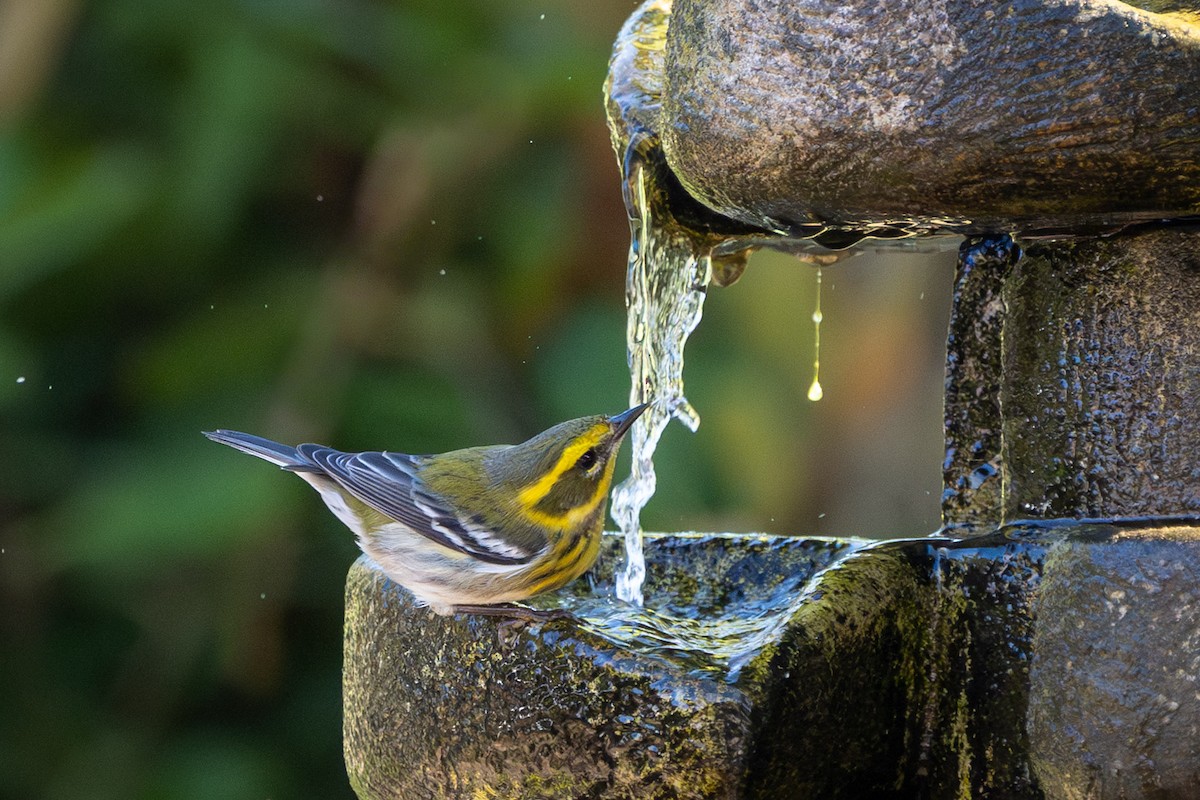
[745,533,1044,800]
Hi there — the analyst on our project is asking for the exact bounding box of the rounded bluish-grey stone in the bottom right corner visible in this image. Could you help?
[1028,528,1200,800]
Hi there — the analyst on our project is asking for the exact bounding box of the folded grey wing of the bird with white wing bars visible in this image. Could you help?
[296,445,536,565]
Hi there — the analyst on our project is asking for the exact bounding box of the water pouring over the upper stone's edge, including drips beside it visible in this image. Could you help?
[605,0,862,606]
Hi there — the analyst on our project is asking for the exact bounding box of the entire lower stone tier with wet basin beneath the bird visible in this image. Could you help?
[344,523,1200,799]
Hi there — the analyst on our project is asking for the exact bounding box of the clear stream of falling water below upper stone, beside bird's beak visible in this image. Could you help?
[612,153,713,606]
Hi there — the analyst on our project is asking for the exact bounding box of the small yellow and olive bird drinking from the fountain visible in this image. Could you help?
[204,403,649,615]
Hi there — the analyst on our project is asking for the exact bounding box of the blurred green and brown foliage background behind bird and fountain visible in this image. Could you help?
[0,0,952,799]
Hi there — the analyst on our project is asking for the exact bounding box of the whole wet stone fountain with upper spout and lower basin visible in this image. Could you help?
[344,0,1200,800]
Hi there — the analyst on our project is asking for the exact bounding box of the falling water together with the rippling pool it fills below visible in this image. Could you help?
[592,0,857,652]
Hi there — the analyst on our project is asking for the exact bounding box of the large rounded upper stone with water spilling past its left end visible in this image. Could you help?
[658,0,1200,233]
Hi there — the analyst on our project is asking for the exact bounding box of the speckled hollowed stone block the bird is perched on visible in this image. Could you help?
[343,536,847,799]
